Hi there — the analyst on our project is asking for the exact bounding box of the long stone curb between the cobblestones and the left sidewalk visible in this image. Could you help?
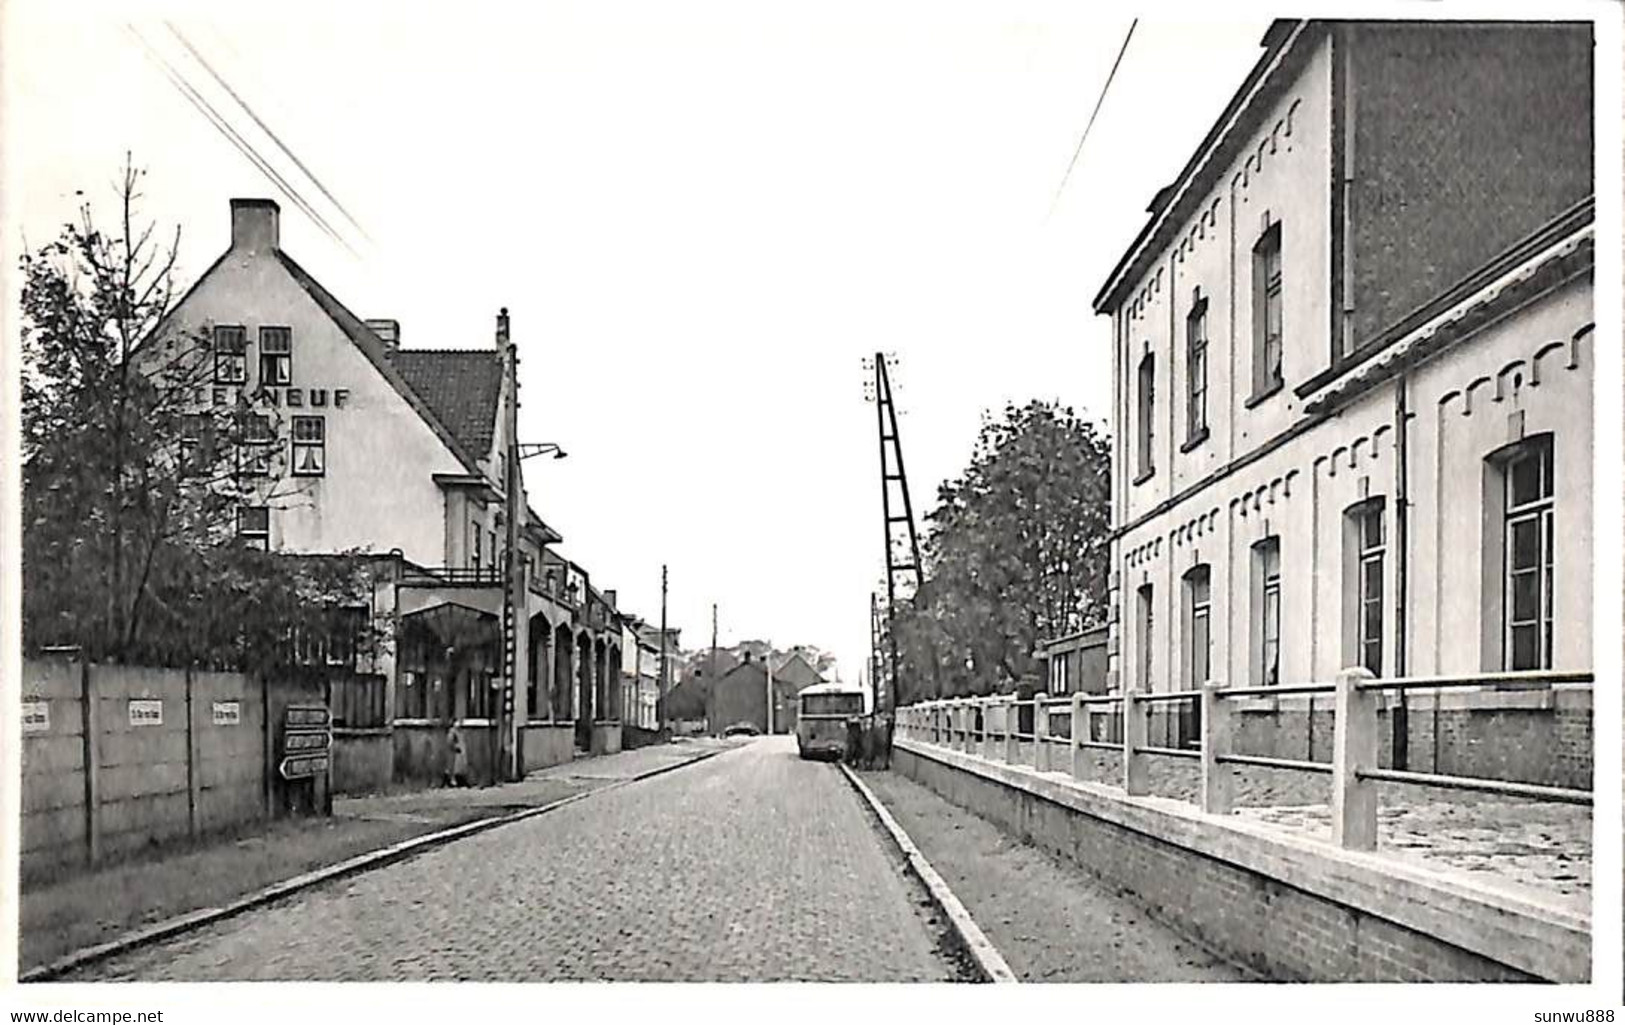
[16,747,733,983]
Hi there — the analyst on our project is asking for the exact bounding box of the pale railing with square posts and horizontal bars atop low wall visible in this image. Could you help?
[897,669,1596,851]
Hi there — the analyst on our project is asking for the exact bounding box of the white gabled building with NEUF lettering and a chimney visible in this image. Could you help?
[159,200,622,789]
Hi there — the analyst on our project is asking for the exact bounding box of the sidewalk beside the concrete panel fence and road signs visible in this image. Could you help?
[18,737,738,971]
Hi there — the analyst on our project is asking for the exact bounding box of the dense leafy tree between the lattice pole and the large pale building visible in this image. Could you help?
[894,401,1112,703]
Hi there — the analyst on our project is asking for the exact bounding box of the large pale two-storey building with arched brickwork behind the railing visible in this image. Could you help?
[1095,21,1594,780]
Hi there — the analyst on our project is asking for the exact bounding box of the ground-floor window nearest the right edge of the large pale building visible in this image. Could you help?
[1502,434,1555,671]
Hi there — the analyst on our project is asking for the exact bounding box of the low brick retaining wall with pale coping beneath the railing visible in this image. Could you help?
[892,742,1589,981]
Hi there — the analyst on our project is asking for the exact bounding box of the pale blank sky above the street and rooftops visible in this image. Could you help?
[0,0,1269,681]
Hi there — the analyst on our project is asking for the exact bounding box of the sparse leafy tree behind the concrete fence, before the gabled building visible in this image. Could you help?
[21,162,377,666]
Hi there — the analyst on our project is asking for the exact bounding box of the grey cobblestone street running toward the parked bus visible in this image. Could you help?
[65,737,954,981]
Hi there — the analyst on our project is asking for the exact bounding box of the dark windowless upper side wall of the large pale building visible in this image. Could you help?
[1342,23,1594,341]
